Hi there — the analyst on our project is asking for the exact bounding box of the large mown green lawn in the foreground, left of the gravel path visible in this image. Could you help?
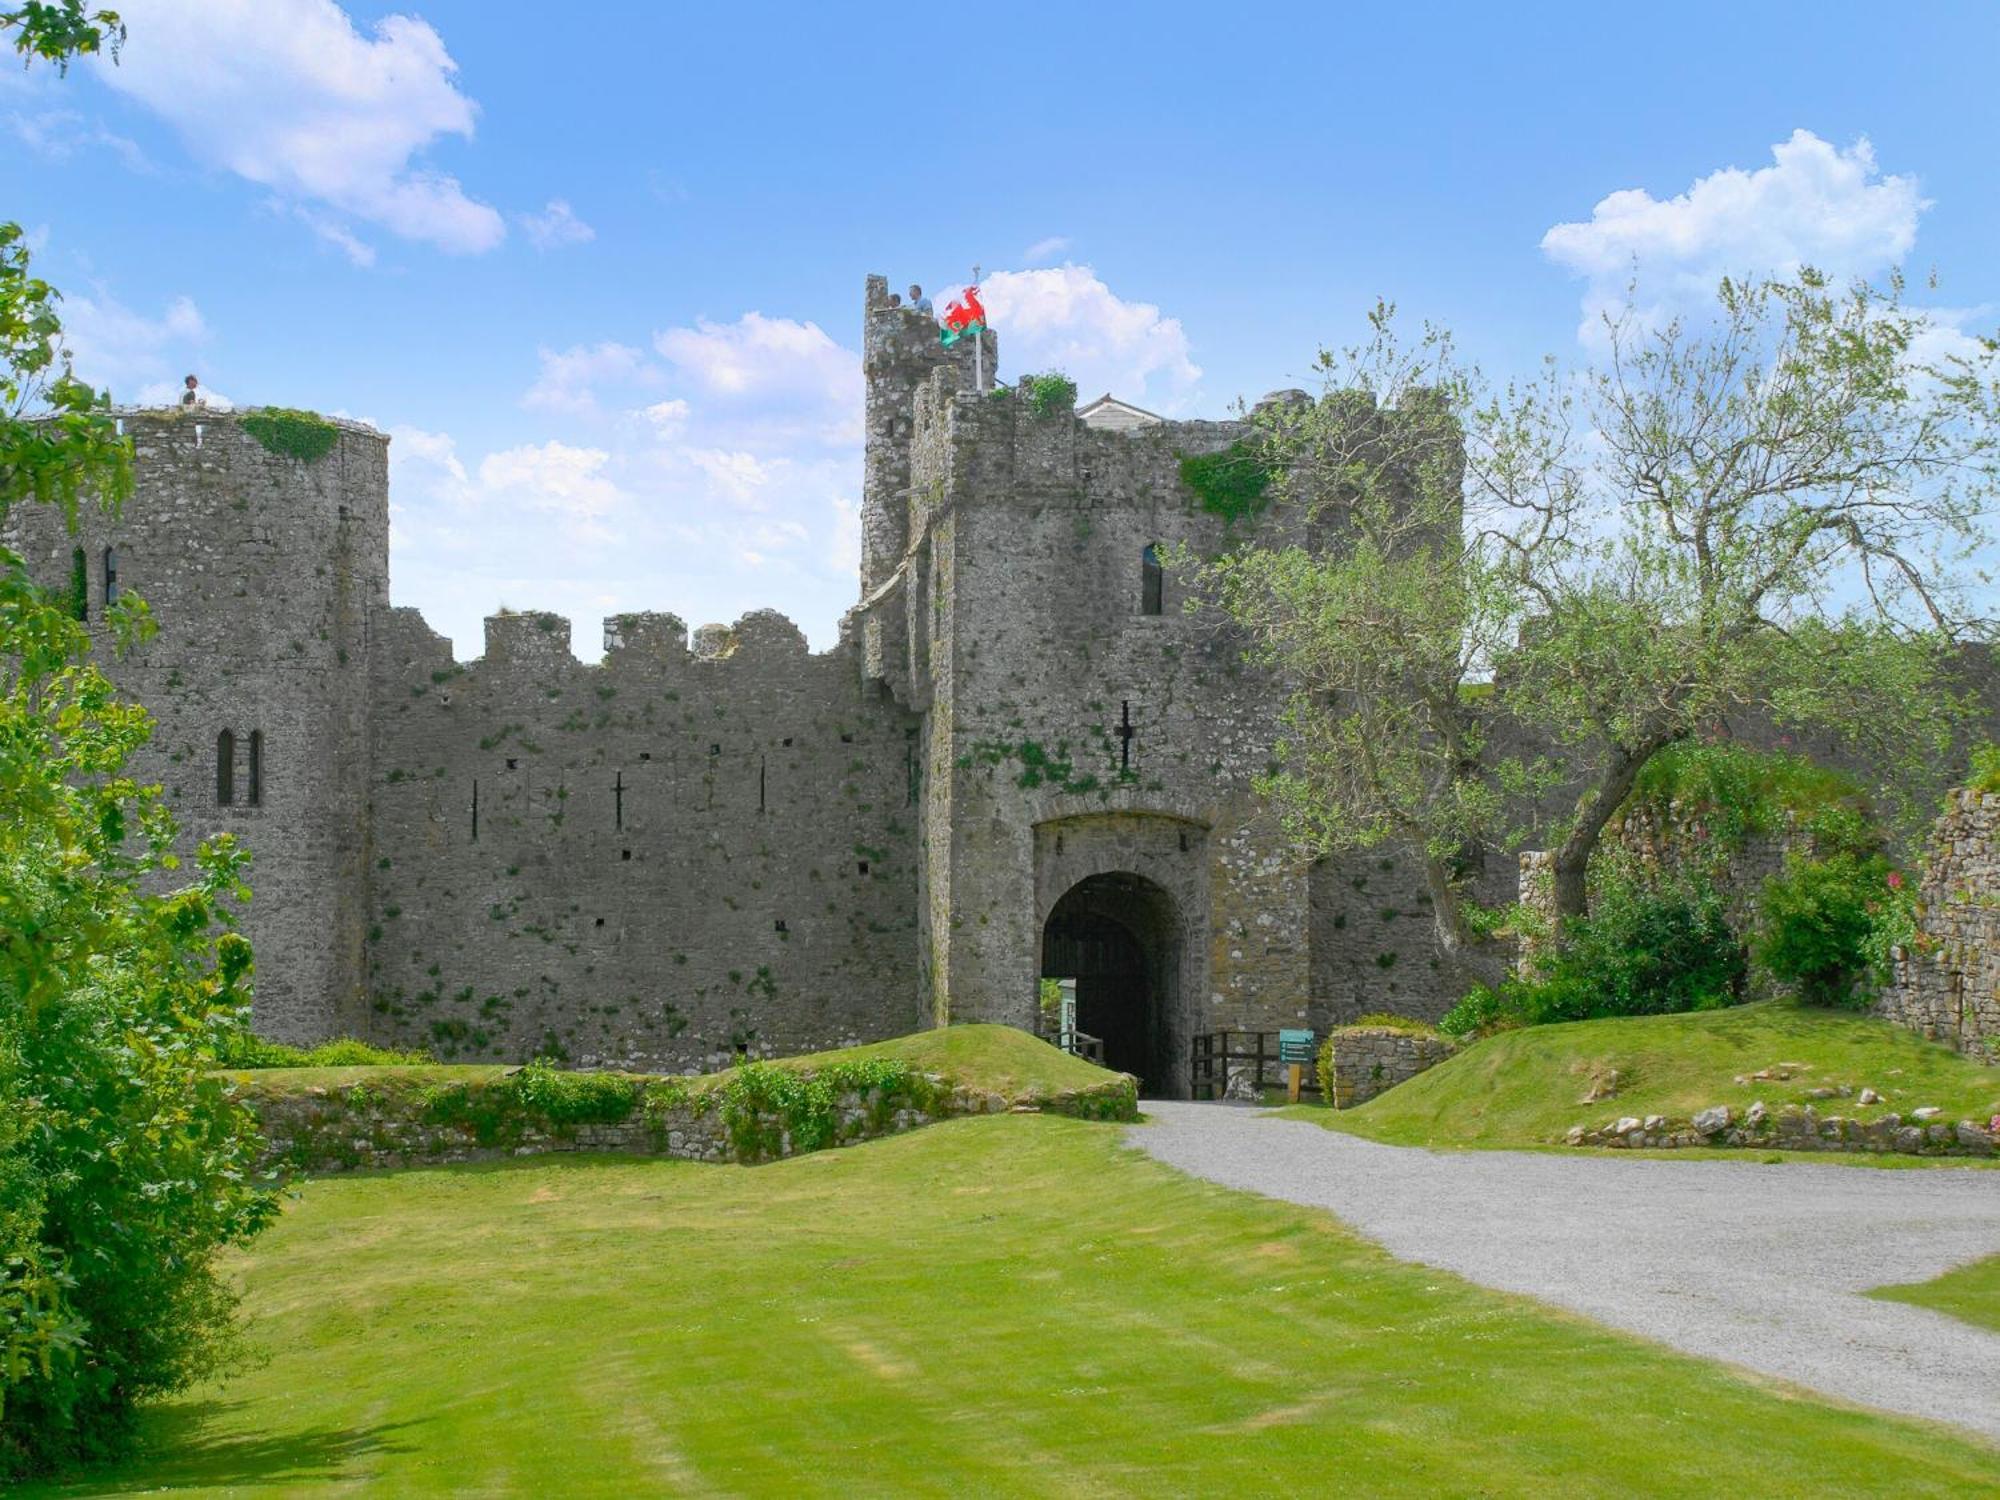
[22,1116,2000,1500]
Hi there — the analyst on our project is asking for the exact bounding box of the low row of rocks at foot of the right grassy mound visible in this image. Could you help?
[1564,1104,1994,1156]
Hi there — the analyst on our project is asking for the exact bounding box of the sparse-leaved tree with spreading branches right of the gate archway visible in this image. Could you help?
[1180,270,2000,954]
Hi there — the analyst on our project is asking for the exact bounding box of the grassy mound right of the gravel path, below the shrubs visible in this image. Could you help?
[1314,1000,2000,1146]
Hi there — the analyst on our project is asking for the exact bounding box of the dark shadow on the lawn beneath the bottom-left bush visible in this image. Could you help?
[28,1400,416,1496]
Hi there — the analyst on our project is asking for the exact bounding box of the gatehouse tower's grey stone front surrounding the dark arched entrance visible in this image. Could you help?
[910,378,1308,1028]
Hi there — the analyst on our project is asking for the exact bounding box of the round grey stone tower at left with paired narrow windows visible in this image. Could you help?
[8,408,388,1040]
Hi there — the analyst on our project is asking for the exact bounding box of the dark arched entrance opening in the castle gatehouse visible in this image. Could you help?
[1042,870,1190,1098]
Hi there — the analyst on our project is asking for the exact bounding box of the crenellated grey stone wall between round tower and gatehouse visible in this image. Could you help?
[368,610,922,1070]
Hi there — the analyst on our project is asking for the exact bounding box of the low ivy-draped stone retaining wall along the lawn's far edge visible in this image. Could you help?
[246,1070,1138,1172]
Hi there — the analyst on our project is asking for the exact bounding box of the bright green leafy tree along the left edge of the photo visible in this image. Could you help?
[0,4,276,1478]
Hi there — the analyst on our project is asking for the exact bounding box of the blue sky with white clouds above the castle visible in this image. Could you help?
[0,0,2000,658]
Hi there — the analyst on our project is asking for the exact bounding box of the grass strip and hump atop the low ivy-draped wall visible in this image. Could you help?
[230,1026,1110,1098]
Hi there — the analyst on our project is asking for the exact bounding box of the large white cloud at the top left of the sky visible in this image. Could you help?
[96,0,506,254]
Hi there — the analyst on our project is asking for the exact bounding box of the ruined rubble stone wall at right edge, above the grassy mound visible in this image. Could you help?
[1876,790,2000,1062]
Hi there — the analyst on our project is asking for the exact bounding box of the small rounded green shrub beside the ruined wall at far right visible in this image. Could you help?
[1756,852,1914,1008]
